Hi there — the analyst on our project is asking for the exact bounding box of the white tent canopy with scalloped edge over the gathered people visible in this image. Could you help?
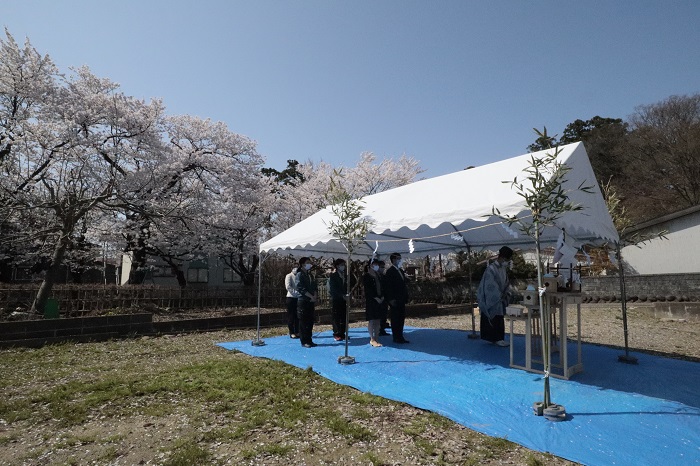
[260,143,619,258]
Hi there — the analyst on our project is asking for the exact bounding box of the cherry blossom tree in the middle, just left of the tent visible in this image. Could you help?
[121,116,271,286]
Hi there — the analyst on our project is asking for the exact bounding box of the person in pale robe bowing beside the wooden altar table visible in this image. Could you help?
[476,246,513,346]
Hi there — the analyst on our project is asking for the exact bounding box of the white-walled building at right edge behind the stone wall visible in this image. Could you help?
[622,205,700,275]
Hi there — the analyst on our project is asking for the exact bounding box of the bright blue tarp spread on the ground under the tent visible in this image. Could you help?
[219,328,700,465]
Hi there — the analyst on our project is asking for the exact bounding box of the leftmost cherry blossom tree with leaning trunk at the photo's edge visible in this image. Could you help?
[2,45,161,312]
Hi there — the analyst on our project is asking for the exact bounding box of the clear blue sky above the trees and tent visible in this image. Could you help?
[0,0,700,177]
